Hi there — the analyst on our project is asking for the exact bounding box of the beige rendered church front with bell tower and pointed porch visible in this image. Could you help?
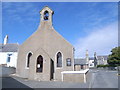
[16,6,74,81]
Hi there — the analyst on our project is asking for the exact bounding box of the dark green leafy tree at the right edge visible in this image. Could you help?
[108,46,120,67]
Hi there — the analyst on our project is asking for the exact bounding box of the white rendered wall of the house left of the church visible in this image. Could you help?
[0,52,18,68]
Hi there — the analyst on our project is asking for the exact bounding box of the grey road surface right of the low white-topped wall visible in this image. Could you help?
[89,70,118,88]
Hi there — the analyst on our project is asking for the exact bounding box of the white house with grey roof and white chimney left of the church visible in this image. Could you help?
[0,35,19,68]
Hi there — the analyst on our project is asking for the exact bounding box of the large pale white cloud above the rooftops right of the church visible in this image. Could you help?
[74,22,118,57]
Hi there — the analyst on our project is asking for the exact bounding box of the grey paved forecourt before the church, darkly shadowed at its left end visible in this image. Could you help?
[2,76,88,88]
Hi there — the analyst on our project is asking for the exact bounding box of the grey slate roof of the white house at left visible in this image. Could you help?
[0,43,19,52]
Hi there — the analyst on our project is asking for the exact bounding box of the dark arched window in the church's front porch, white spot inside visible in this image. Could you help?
[36,55,43,72]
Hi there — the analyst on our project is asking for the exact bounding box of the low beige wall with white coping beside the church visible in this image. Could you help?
[61,69,89,83]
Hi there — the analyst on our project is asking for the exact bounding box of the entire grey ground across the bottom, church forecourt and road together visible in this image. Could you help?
[0,69,118,90]
